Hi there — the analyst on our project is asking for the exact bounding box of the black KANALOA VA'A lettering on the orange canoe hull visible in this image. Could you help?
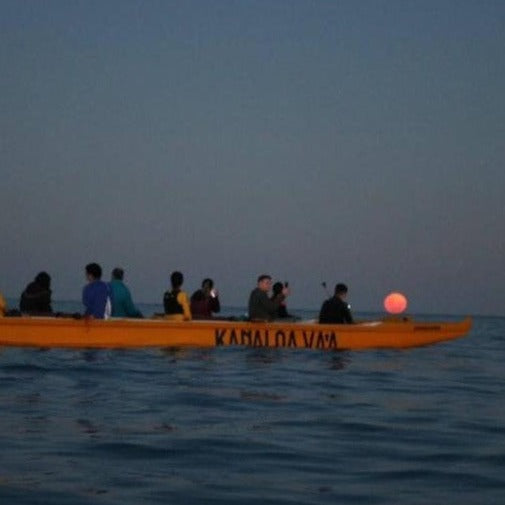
[214,328,337,349]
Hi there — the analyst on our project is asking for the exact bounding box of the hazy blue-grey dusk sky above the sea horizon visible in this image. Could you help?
[0,0,505,316]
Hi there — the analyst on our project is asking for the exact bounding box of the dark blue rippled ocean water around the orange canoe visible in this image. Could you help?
[0,306,505,505]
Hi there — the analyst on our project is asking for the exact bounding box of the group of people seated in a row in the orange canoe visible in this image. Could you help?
[0,263,354,324]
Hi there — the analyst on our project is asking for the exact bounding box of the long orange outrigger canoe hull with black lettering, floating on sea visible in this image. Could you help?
[0,317,472,350]
